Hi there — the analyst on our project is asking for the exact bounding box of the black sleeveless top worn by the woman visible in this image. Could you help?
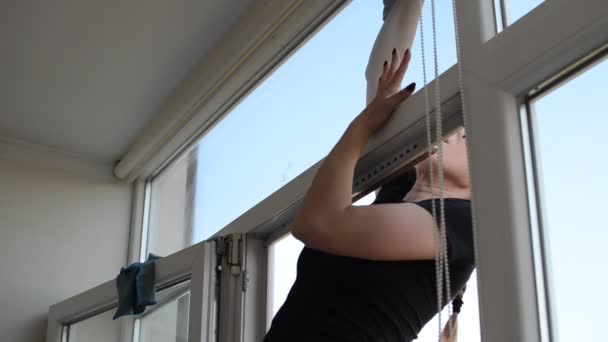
[264,199,475,342]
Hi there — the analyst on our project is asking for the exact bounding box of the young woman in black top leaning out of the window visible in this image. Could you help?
[264,0,474,342]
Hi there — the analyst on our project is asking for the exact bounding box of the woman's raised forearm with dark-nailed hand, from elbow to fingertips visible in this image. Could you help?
[292,45,416,242]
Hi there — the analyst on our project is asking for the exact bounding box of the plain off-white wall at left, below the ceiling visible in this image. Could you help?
[0,141,131,342]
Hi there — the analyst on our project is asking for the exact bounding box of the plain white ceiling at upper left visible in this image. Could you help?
[0,0,253,162]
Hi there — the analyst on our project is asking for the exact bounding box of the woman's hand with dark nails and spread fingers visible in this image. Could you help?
[353,49,416,135]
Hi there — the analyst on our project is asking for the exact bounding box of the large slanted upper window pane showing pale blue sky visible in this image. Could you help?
[193,1,456,246]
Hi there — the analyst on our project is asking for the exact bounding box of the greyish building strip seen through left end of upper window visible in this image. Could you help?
[144,153,196,256]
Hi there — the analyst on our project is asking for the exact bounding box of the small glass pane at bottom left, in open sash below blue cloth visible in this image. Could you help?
[68,309,120,342]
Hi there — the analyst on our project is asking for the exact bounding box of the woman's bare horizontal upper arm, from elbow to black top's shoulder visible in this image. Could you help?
[294,203,436,260]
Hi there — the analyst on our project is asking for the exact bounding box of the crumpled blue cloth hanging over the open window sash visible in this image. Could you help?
[114,253,160,319]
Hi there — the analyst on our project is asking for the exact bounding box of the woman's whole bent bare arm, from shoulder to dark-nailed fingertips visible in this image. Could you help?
[292,50,434,260]
